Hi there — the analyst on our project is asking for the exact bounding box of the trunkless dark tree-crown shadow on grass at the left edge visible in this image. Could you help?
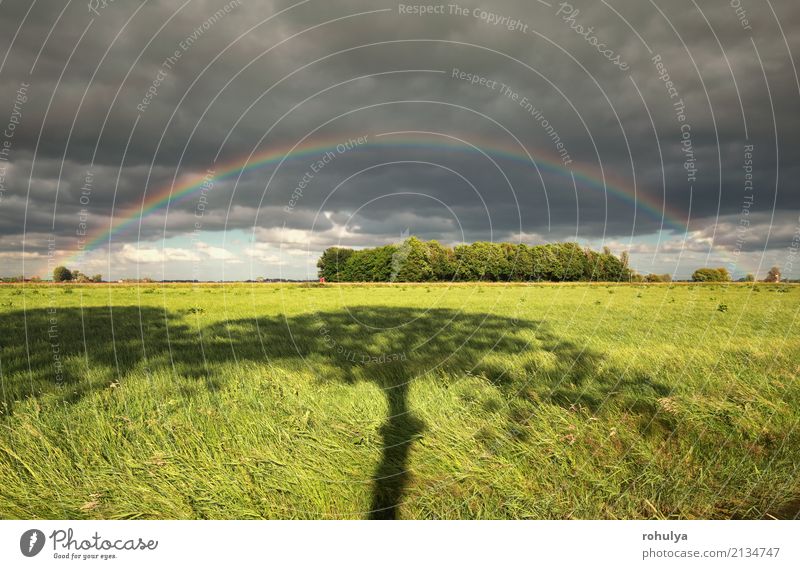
[0,306,189,416]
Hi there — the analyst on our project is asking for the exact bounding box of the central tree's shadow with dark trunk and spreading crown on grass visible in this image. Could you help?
[198,306,633,519]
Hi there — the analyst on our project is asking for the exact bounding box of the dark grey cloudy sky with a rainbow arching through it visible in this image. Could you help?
[0,0,800,280]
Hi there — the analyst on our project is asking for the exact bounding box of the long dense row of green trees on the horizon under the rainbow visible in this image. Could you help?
[317,237,632,282]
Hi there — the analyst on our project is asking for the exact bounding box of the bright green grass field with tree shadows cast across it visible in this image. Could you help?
[0,284,800,519]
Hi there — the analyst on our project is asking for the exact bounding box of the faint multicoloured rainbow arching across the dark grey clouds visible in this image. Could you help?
[69,133,688,261]
